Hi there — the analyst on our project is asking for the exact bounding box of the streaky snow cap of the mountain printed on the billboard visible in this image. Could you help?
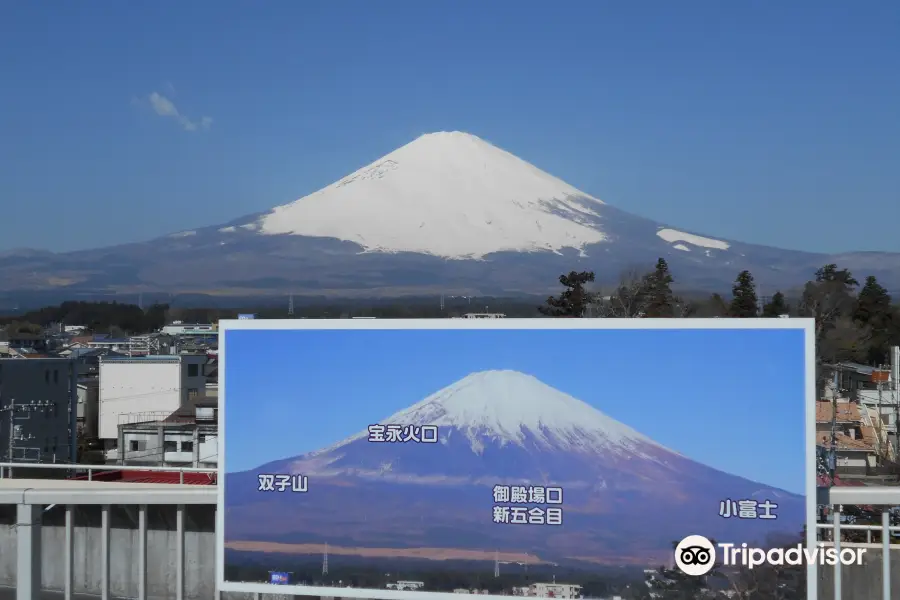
[341,371,661,452]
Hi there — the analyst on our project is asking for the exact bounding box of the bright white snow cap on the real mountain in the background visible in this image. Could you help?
[258,131,606,259]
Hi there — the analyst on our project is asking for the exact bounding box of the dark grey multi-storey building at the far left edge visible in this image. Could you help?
[0,358,77,463]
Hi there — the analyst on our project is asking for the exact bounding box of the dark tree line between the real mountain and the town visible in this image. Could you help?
[0,259,900,372]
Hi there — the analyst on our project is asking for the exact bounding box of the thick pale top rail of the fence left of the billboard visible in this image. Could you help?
[0,479,218,504]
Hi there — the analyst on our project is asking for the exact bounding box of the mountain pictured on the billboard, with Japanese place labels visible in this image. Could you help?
[224,371,805,566]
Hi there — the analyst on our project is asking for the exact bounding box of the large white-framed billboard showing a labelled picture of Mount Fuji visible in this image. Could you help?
[217,319,816,600]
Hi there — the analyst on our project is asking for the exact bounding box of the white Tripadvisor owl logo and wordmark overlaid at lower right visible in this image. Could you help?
[675,535,866,577]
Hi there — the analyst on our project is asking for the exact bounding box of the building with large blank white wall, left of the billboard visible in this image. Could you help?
[97,354,207,449]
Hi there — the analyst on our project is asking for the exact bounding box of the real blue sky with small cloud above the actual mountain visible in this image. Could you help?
[0,0,900,251]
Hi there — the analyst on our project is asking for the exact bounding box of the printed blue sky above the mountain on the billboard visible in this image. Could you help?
[225,330,805,494]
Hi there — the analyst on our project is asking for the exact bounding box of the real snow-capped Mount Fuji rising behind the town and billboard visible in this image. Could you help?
[0,132,900,297]
